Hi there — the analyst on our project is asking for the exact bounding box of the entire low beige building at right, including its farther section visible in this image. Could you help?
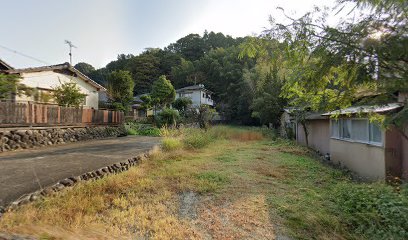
[282,93,408,180]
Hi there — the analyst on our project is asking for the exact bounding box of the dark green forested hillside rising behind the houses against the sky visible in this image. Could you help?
[75,32,280,124]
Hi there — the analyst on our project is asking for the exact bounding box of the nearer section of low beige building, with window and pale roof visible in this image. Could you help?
[323,103,408,179]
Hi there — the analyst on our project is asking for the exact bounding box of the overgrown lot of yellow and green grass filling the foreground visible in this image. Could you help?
[0,127,408,239]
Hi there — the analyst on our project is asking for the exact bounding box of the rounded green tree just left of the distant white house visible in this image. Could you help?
[151,75,176,107]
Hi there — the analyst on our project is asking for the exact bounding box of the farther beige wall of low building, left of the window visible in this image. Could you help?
[296,119,330,155]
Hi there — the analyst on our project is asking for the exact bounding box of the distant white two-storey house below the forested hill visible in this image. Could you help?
[176,84,215,107]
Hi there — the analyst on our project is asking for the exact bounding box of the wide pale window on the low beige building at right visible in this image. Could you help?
[331,119,382,145]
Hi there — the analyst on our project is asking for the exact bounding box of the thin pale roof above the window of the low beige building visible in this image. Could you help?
[322,103,404,116]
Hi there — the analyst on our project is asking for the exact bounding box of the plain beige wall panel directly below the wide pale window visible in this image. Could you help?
[330,139,386,180]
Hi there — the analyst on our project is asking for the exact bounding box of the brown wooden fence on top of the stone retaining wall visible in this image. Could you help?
[0,102,124,127]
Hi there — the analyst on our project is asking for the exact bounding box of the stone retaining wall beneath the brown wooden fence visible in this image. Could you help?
[0,126,126,153]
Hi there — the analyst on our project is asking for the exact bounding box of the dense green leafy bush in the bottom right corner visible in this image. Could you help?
[333,184,408,239]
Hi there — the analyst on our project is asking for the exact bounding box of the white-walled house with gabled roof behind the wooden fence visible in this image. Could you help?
[0,61,106,109]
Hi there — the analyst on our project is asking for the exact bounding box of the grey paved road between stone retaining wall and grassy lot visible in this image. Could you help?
[0,136,160,206]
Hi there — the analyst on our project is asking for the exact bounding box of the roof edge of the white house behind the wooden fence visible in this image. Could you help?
[4,63,106,91]
